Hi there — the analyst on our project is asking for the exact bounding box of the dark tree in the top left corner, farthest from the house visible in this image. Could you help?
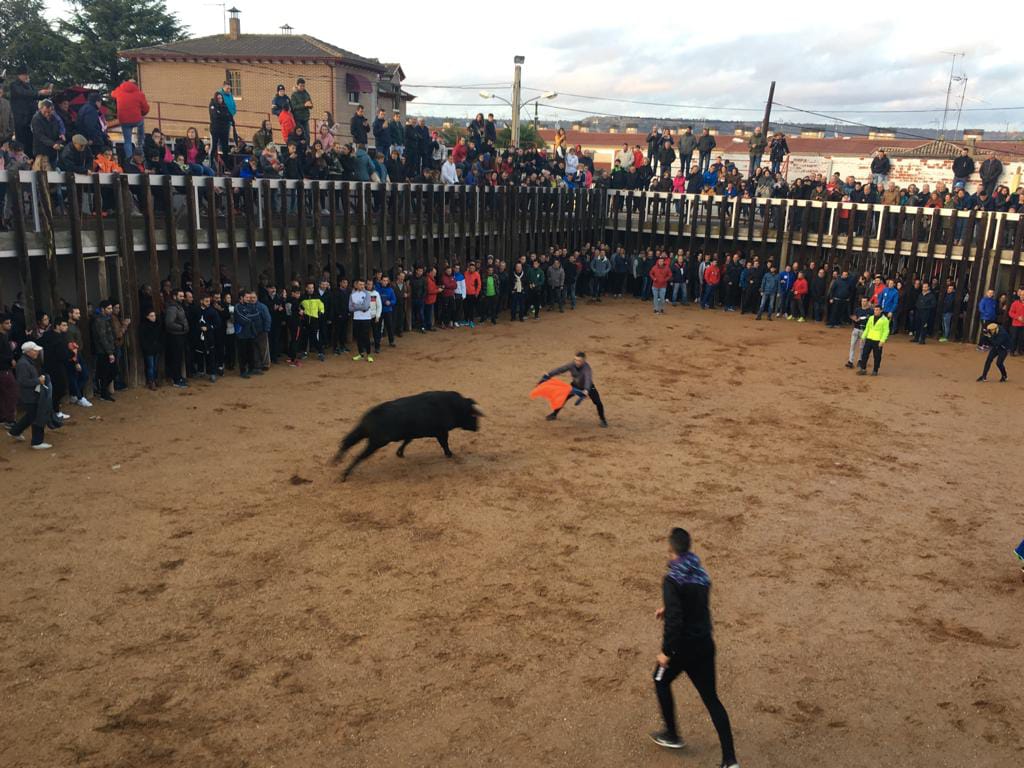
[0,0,68,87]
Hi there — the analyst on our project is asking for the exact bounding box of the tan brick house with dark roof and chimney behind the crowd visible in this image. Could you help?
[120,8,414,141]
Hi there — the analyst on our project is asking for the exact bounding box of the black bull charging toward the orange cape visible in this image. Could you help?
[334,392,482,482]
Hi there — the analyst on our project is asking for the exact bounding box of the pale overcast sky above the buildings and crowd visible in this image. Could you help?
[61,0,1024,130]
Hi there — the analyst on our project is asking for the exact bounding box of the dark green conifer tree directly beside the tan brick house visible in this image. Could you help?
[58,0,186,89]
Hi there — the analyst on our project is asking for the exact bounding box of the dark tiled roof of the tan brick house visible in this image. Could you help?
[120,35,384,72]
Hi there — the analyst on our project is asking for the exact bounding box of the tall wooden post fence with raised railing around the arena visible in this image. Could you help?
[0,172,1024,381]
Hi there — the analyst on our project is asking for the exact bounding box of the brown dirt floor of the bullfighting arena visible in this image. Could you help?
[0,301,1024,768]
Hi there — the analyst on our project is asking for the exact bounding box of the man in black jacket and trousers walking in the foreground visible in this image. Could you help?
[650,528,738,768]
